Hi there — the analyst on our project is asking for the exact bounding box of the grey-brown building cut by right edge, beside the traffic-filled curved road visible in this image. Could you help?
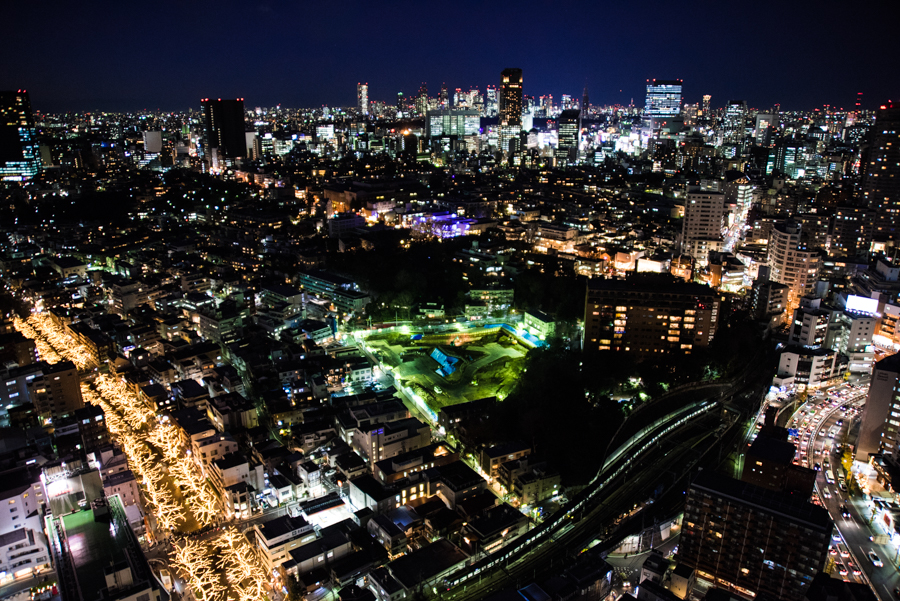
[856,354,900,461]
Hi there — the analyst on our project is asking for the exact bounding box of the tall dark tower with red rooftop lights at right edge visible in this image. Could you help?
[862,104,900,241]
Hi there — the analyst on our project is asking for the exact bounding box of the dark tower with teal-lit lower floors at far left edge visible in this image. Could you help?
[0,90,41,182]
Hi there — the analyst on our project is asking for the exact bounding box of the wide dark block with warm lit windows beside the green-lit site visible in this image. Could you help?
[584,276,719,357]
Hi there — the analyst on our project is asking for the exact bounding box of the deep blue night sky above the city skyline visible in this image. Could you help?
[0,0,900,112]
